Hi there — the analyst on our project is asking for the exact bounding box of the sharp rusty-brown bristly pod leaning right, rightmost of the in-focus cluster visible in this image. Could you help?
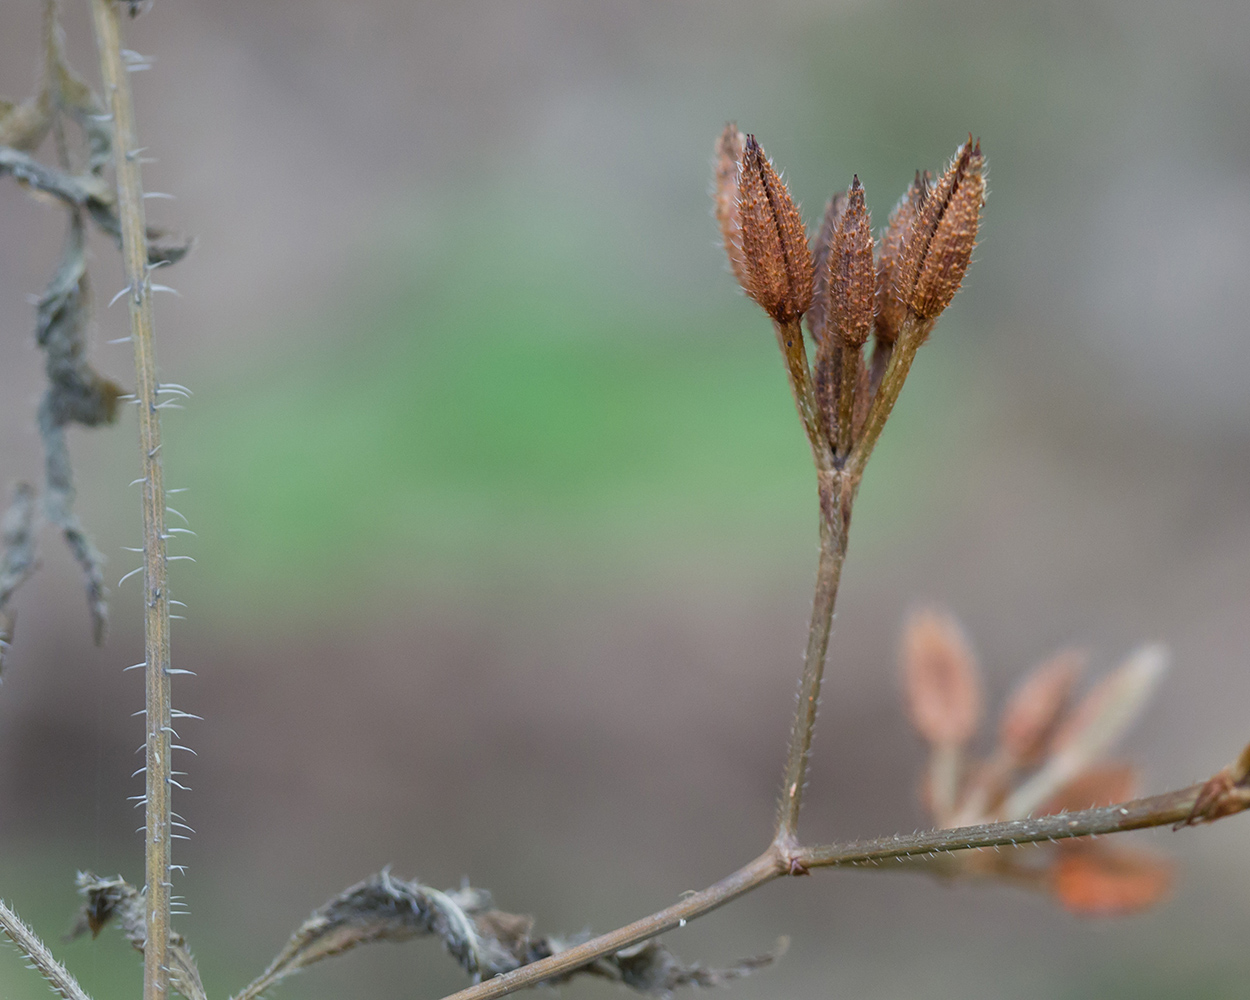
[899,136,985,320]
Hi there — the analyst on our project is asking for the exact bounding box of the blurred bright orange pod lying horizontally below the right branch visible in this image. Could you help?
[1051,845,1173,916]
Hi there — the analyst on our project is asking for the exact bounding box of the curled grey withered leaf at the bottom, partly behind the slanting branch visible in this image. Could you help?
[235,871,776,1000]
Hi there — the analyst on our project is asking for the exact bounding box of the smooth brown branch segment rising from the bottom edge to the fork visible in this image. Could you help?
[435,849,786,1000]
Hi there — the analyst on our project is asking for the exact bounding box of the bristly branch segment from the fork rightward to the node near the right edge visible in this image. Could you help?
[795,783,1220,869]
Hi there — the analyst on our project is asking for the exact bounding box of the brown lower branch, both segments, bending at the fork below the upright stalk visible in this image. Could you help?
[444,784,1235,1000]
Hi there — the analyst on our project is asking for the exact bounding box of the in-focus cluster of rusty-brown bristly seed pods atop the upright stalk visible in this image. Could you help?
[715,124,985,464]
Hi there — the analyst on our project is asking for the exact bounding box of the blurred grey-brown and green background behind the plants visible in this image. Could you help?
[0,0,1250,1000]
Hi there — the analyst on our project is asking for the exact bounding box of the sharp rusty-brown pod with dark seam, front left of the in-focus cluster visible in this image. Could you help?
[738,135,811,324]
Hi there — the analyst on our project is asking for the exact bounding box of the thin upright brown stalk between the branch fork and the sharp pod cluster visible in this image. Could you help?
[776,474,850,846]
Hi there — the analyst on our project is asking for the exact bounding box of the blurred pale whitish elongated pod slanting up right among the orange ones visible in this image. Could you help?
[1004,645,1168,819]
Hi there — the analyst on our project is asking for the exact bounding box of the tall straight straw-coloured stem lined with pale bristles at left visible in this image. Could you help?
[91,0,170,1000]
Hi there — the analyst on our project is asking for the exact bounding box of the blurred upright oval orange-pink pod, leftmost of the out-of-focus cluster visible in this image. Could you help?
[901,609,981,746]
